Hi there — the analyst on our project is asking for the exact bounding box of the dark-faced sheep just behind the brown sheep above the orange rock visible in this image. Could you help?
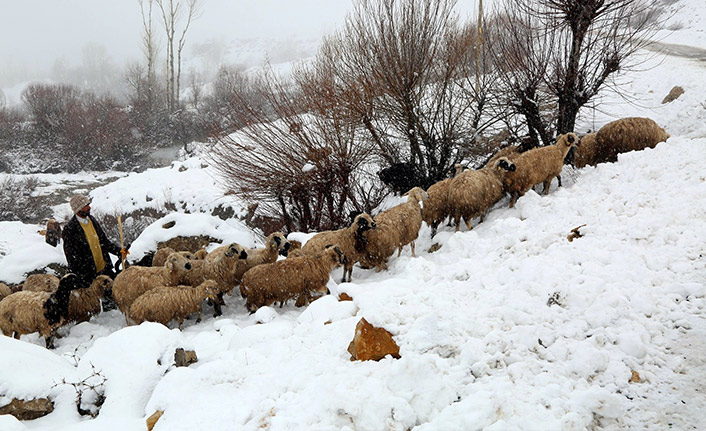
[299,213,376,283]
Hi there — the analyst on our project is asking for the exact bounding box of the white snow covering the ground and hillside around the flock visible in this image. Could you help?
[0,2,706,431]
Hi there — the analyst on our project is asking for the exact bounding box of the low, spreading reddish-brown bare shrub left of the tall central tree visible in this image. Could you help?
[212,68,383,231]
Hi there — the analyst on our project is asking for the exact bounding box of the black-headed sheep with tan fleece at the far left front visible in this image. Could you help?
[0,273,79,349]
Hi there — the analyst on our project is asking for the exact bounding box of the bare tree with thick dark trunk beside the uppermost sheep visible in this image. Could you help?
[503,0,658,138]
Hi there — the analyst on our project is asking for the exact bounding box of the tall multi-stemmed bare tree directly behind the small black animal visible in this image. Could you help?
[310,0,498,187]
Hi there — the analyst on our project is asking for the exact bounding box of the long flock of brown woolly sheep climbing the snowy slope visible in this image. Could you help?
[0,118,669,348]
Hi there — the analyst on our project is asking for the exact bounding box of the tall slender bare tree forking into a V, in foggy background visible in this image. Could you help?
[155,0,202,112]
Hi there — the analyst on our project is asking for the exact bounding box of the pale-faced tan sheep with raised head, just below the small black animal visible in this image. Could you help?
[361,187,428,272]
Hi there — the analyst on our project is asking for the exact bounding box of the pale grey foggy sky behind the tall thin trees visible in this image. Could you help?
[0,0,476,104]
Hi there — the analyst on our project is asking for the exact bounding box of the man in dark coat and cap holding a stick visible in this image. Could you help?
[61,195,128,310]
